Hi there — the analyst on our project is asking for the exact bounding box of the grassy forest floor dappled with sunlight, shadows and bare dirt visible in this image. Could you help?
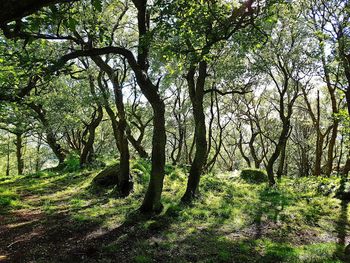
[0,162,350,263]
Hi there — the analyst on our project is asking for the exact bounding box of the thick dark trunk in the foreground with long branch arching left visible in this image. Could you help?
[45,0,166,213]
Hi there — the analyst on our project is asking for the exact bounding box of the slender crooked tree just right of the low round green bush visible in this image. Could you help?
[253,4,311,186]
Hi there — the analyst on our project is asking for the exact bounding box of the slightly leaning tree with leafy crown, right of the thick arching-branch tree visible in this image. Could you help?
[160,1,266,203]
